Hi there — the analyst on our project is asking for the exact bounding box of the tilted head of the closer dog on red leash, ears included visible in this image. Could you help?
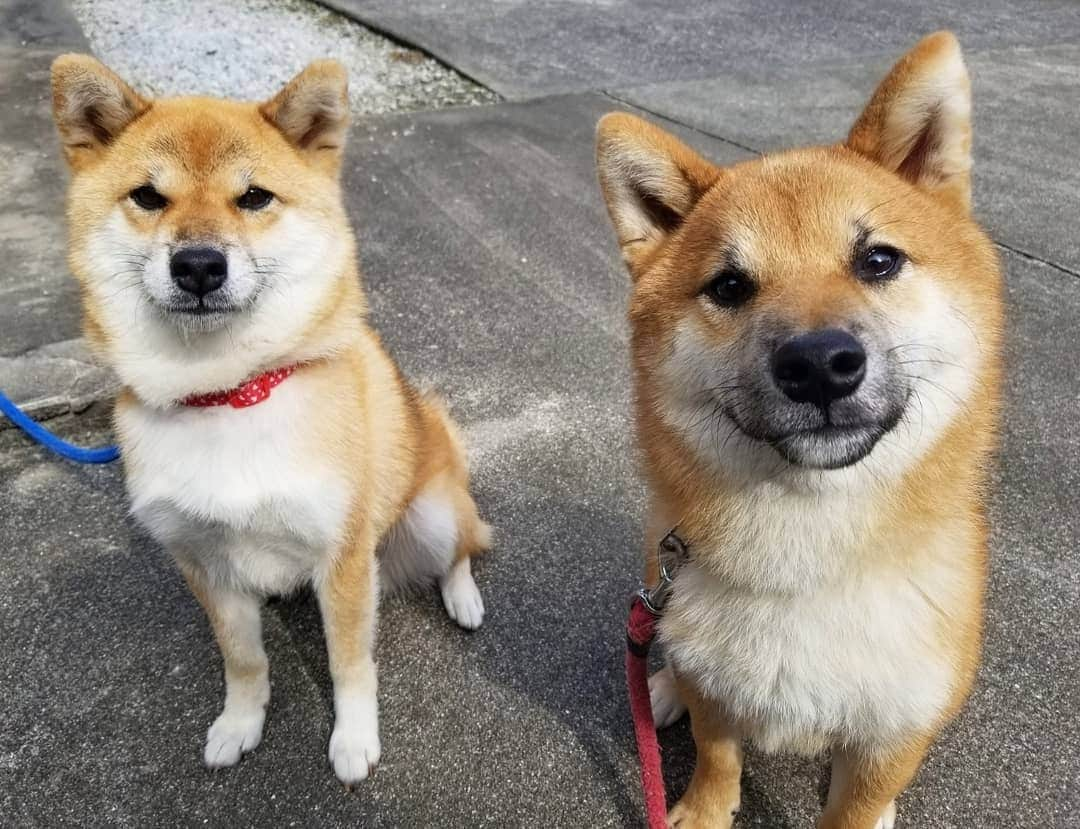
[599,36,997,476]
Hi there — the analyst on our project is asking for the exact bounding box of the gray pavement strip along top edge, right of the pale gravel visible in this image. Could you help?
[321,0,1078,98]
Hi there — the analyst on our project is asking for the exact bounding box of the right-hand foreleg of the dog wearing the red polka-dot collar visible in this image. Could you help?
[316,540,381,785]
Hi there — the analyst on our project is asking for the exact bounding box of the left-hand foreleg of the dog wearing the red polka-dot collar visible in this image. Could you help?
[180,561,270,769]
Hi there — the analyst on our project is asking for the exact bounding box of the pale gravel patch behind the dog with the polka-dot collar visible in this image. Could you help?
[71,0,498,113]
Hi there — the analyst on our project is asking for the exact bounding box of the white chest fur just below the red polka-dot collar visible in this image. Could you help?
[118,377,350,593]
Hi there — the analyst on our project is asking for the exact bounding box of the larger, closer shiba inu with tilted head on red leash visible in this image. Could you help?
[597,32,1002,829]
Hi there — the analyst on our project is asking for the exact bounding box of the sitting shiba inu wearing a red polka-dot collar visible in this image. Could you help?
[52,55,489,784]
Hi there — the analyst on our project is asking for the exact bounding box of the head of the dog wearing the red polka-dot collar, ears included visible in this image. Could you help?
[53,55,350,351]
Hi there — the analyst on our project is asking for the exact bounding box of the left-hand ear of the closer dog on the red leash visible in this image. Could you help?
[596,112,720,278]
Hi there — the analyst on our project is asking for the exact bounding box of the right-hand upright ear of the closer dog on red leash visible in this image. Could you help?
[847,31,971,210]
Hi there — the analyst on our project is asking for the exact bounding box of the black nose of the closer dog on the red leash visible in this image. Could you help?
[772,328,866,409]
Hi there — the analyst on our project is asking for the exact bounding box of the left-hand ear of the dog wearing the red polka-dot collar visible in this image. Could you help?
[52,54,150,168]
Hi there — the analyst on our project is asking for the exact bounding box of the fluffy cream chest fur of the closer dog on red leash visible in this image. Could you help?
[661,492,963,753]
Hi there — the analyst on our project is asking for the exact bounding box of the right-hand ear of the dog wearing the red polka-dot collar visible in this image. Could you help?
[259,60,349,167]
